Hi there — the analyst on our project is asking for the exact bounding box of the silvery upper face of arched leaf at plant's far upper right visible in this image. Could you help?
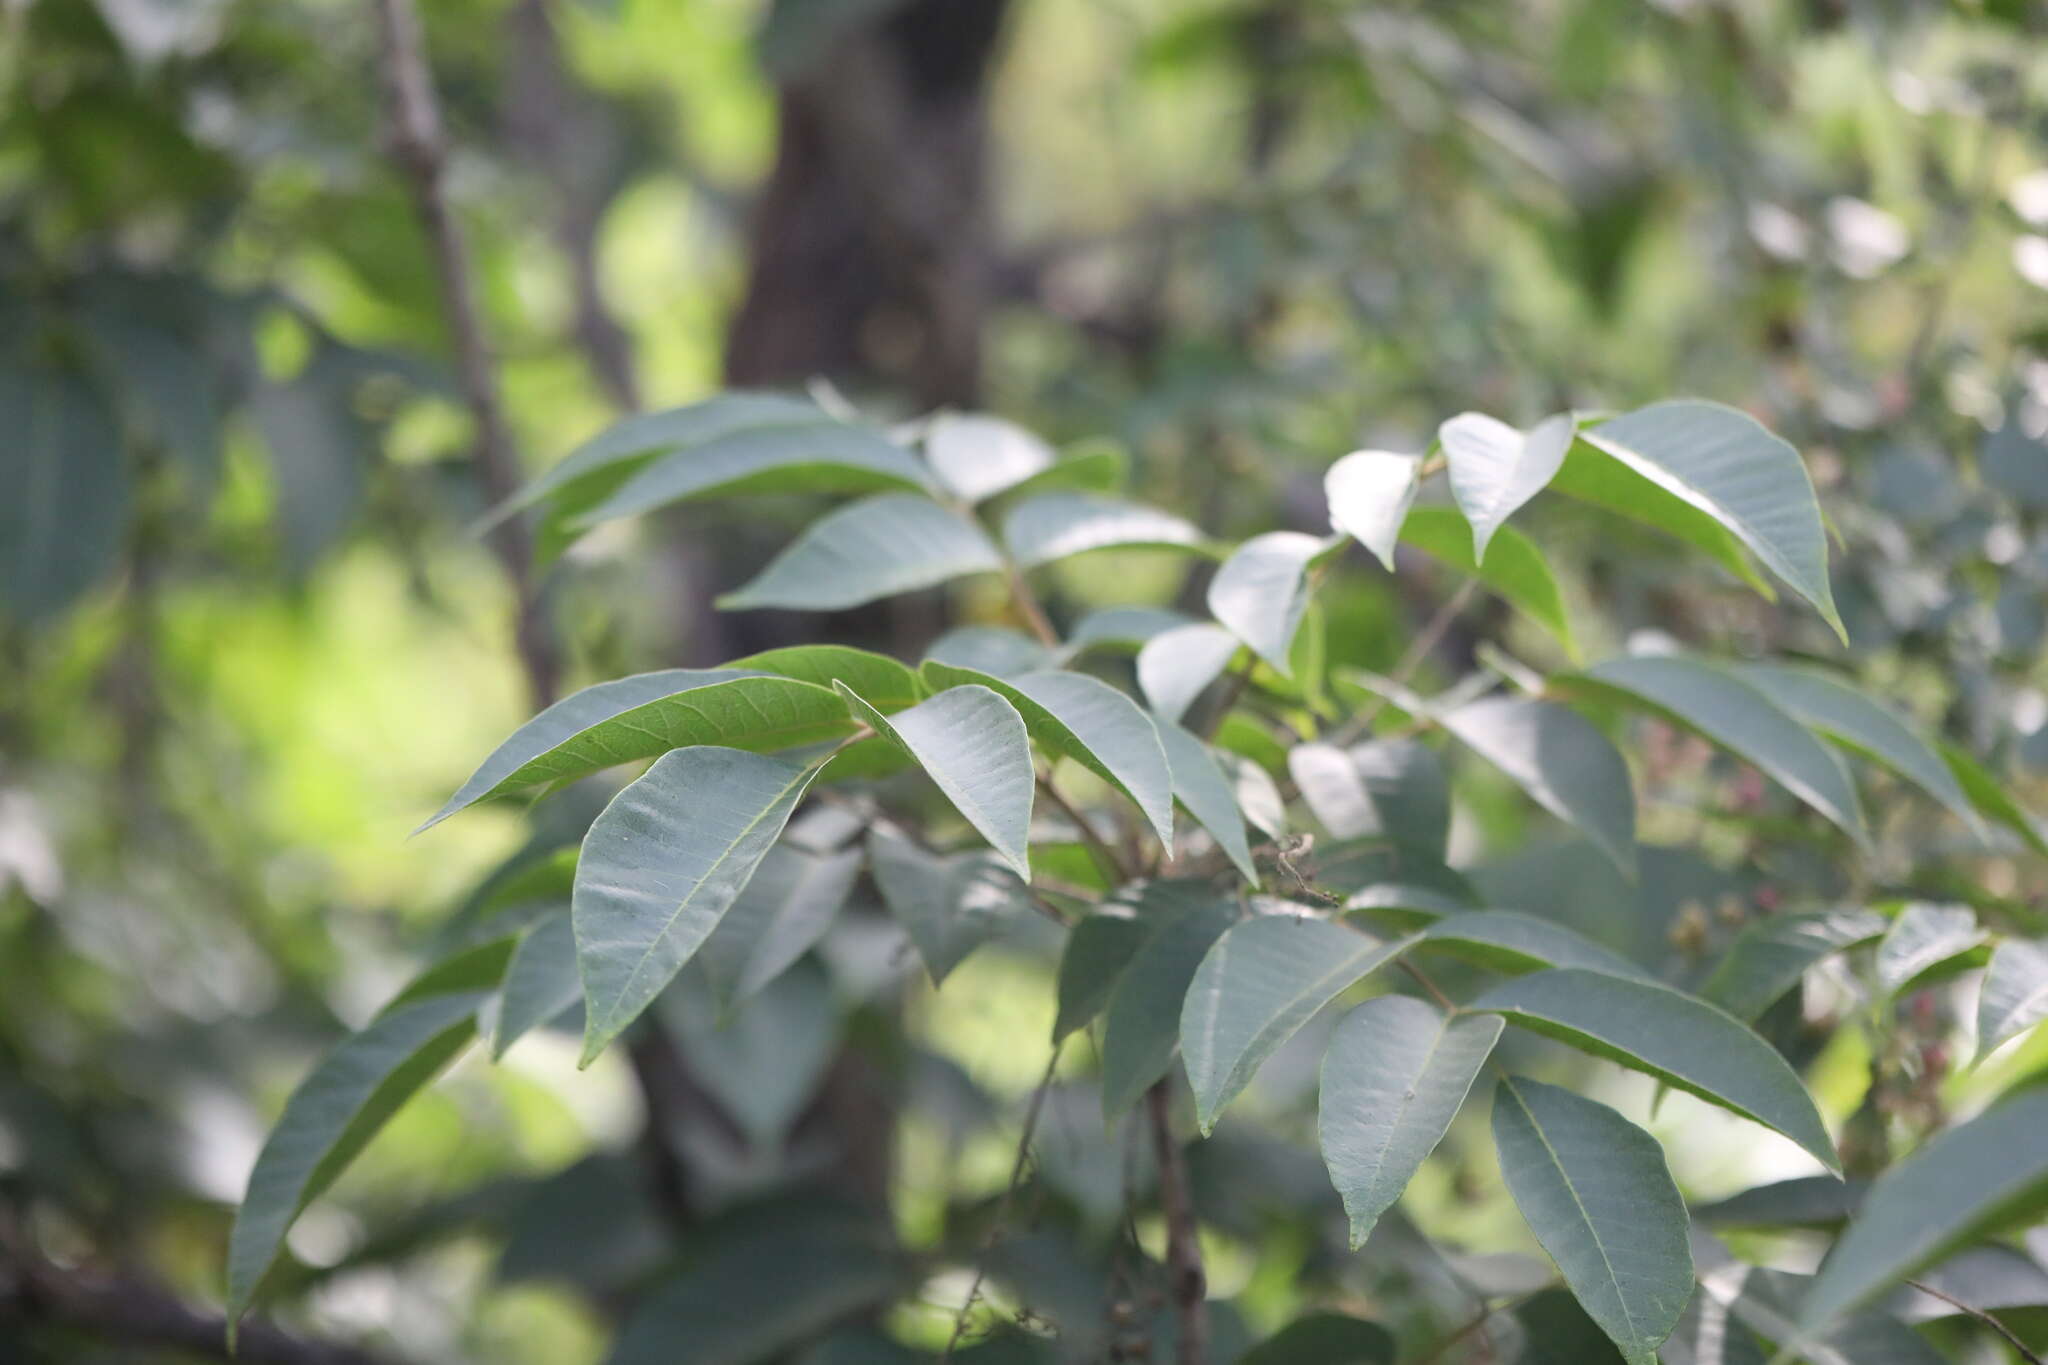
[1583,399,1849,643]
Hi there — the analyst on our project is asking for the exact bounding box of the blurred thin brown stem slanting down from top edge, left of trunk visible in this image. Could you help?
[371,0,561,706]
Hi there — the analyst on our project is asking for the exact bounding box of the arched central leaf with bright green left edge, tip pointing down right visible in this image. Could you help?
[924,661,1174,845]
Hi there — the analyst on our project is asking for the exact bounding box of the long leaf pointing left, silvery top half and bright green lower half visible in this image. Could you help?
[414,669,854,833]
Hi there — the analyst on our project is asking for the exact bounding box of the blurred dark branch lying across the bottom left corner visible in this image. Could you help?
[0,1246,409,1365]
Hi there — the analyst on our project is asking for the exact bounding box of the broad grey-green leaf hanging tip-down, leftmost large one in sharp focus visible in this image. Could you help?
[571,753,819,1066]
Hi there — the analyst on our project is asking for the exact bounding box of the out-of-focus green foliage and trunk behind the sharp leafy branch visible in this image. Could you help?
[0,0,2048,1365]
